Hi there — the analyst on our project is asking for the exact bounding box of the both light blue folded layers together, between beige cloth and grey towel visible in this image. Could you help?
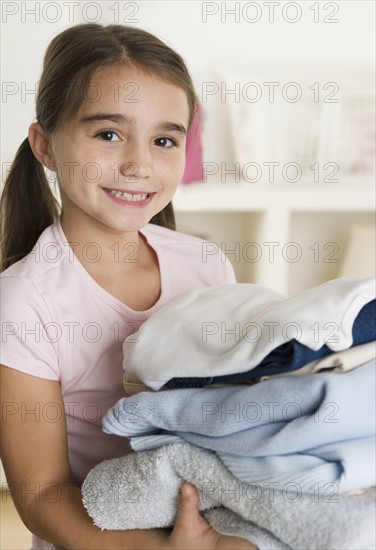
[103,359,376,494]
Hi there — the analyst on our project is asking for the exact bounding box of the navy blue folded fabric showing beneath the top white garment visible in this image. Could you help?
[163,300,376,389]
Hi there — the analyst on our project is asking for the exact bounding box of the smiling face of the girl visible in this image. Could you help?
[50,66,189,233]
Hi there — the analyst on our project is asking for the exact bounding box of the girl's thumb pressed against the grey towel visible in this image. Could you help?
[174,483,208,534]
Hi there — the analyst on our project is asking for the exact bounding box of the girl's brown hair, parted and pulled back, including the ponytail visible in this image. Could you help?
[0,23,196,270]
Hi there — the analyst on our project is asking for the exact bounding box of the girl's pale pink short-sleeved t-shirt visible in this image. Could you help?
[0,221,235,549]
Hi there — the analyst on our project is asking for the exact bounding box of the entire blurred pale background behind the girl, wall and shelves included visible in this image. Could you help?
[1,0,376,550]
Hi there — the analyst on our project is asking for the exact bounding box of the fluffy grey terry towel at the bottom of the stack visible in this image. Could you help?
[82,443,376,550]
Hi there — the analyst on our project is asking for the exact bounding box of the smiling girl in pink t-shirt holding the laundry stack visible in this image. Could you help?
[1,24,252,550]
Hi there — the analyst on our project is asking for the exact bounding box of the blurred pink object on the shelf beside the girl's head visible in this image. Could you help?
[181,98,204,183]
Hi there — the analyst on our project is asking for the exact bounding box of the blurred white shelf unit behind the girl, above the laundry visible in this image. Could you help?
[173,63,376,294]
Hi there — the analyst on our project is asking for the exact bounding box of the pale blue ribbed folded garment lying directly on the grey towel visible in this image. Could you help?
[131,435,376,493]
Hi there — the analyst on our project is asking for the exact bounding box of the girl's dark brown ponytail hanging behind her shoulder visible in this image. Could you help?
[0,138,60,271]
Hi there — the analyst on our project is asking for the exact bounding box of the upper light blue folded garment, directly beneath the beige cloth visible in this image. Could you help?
[103,360,375,457]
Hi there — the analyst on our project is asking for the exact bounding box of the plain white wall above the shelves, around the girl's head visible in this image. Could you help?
[1,0,375,168]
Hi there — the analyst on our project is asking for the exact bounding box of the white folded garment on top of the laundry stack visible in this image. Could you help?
[123,278,376,390]
